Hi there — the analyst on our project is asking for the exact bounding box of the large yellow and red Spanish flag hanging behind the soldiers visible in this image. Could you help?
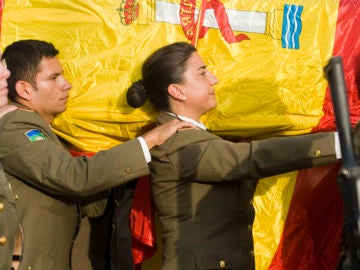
[0,0,360,270]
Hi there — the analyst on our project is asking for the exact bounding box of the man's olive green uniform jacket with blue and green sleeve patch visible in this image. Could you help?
[0,105,149,270]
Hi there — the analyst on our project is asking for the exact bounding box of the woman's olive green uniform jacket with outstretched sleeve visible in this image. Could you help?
[150,110,337,270]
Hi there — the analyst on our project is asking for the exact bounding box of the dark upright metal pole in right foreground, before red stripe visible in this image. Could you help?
[324,57,360,270]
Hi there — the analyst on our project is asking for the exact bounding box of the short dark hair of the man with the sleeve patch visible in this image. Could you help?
[1,39,59,101]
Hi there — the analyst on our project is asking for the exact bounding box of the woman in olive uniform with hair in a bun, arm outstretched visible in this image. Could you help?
[127,42,341,270]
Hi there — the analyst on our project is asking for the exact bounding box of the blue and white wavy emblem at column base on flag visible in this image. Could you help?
[281,4,304,49]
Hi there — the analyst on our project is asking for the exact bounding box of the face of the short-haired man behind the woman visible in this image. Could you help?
[31,57,71,123]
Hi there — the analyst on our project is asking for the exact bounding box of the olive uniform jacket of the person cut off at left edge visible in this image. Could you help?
[0,165,19,270]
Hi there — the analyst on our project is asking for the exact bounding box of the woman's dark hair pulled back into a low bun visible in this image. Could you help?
[126,42,196,111]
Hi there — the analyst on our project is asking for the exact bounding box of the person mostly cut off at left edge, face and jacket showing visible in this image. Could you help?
[0,55,22,270]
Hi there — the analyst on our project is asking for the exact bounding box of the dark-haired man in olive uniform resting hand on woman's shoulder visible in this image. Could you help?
[0,40,194,270]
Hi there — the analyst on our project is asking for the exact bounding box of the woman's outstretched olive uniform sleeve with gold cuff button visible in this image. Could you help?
[152,132,337,182]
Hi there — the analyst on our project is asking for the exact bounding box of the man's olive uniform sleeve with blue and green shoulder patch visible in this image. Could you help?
[0,112,149,196]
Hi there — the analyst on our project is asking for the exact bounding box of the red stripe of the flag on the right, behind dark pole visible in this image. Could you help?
[269,0,360,270]
